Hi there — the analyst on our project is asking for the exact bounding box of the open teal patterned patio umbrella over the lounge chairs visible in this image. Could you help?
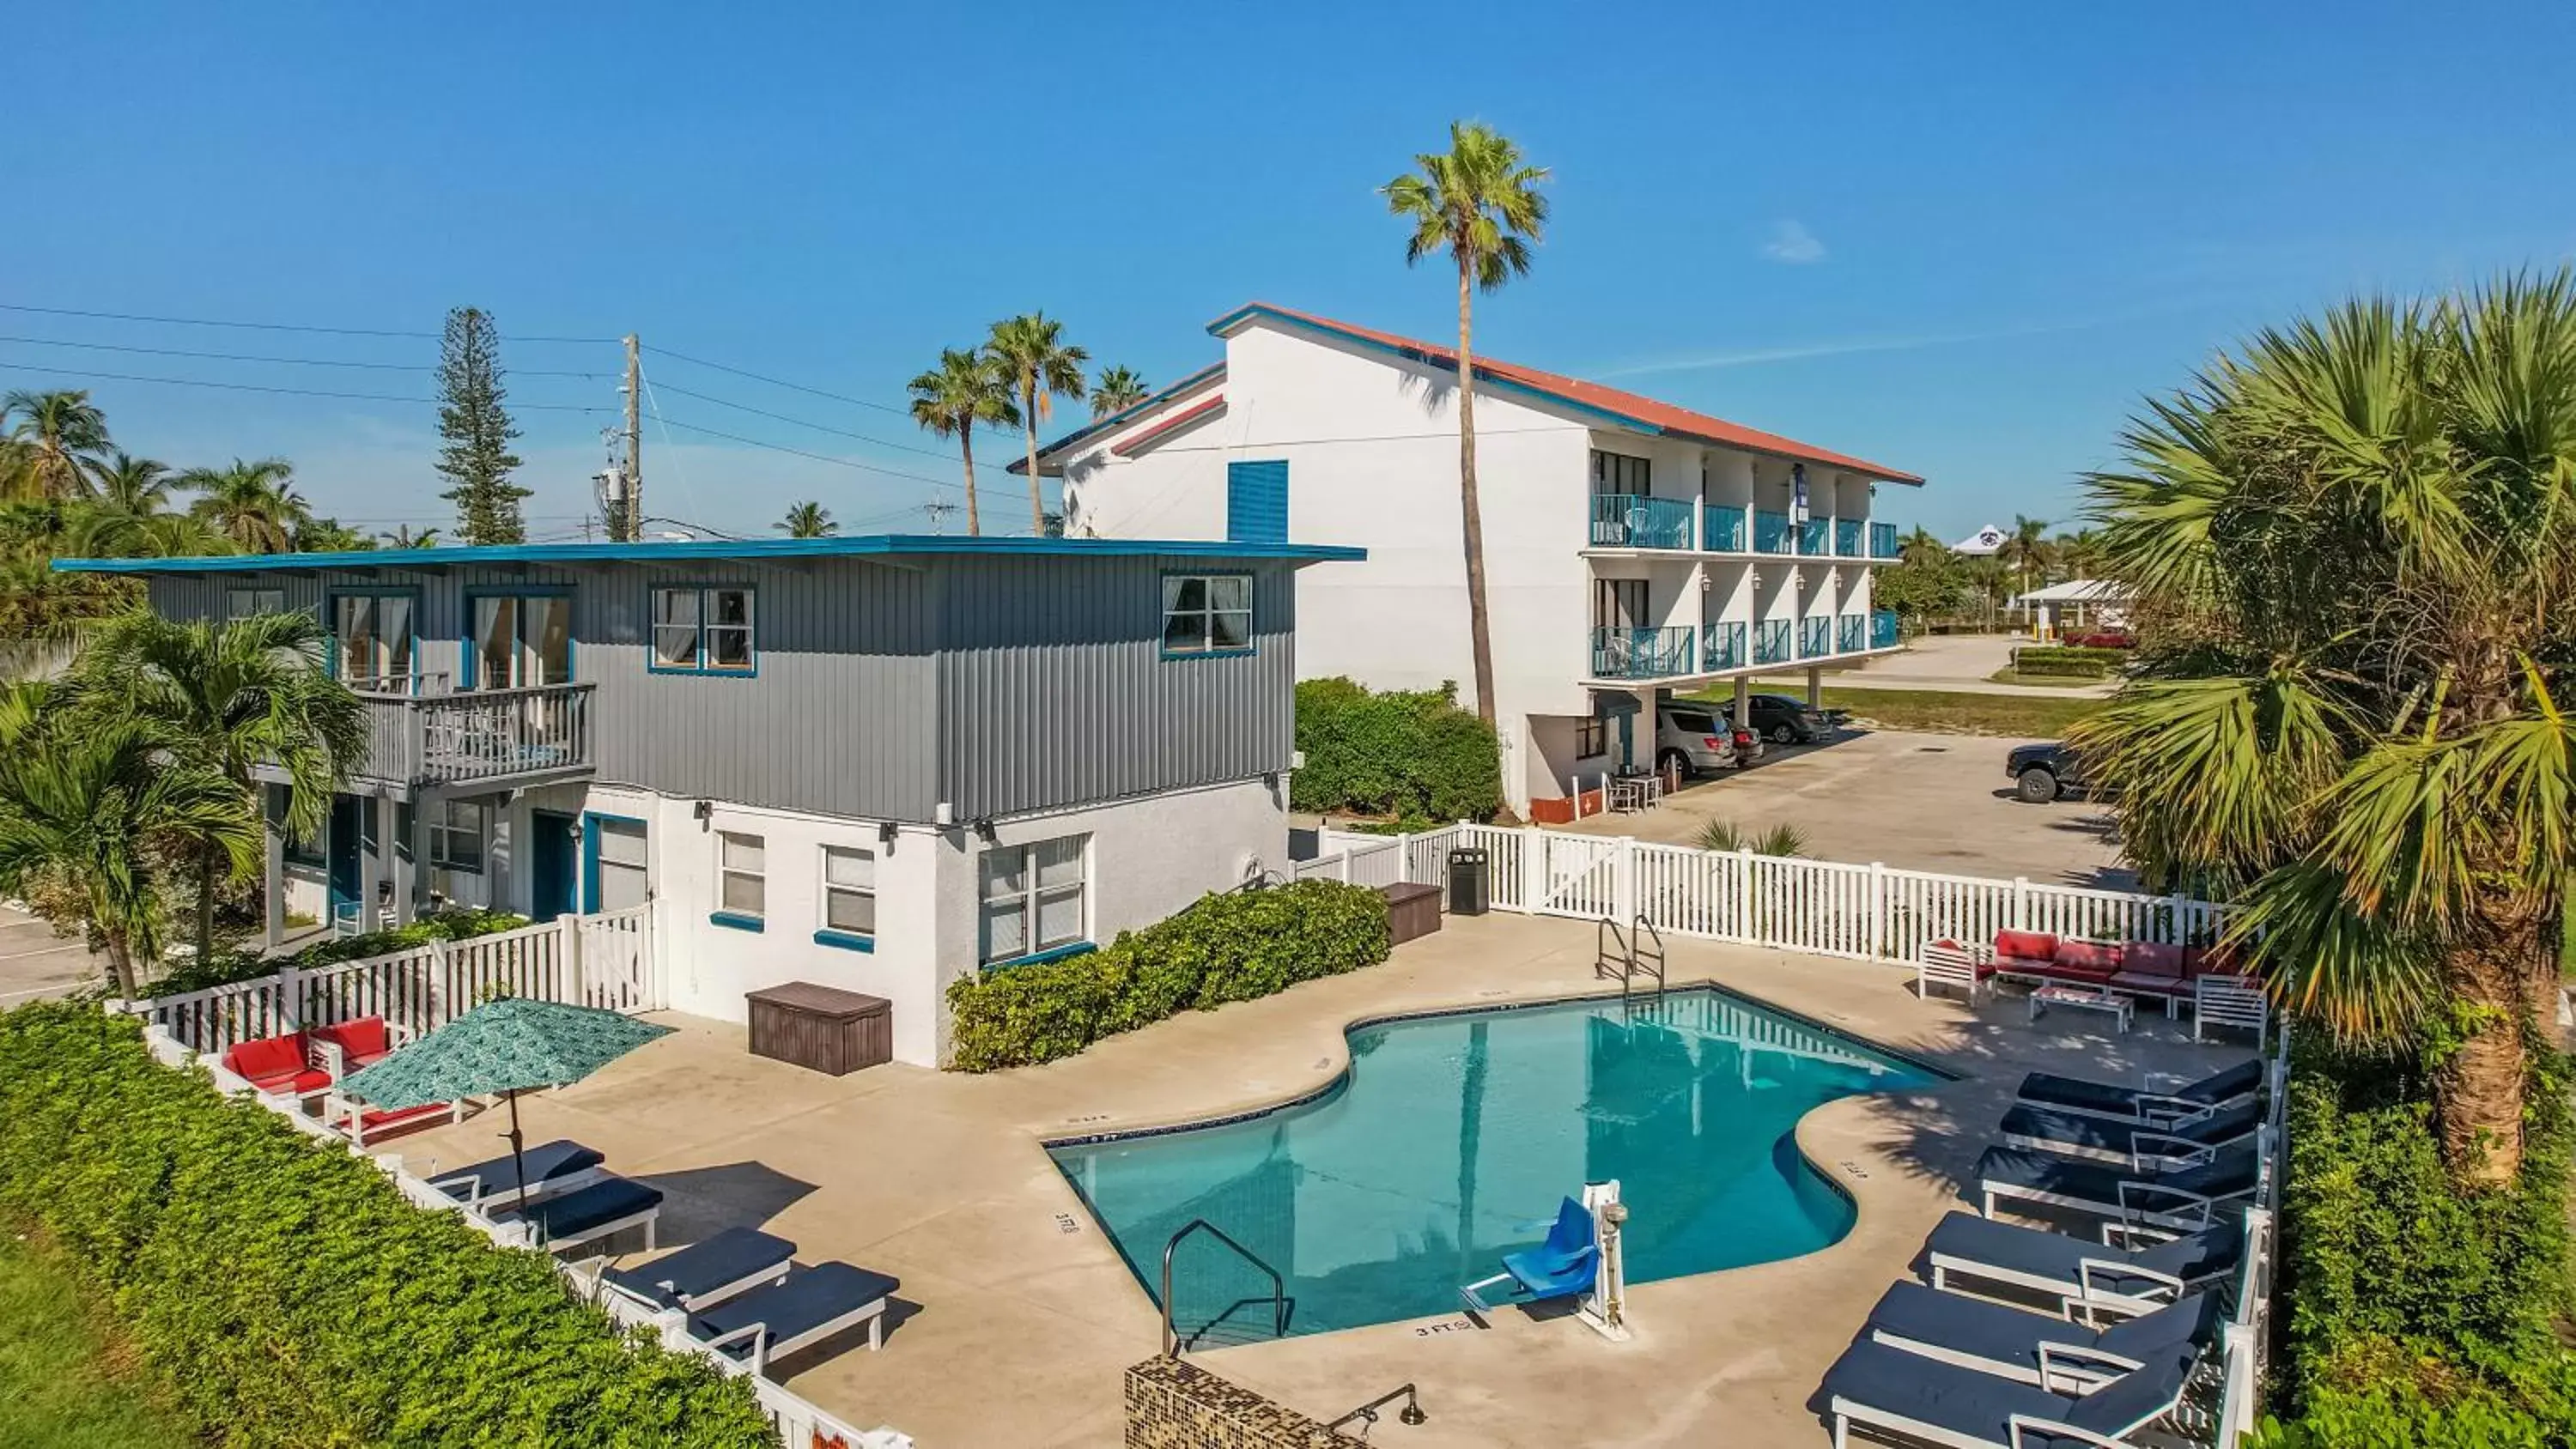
[340,998,670,1189]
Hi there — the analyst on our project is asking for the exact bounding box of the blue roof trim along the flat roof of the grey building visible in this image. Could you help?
[54,533,1368,574]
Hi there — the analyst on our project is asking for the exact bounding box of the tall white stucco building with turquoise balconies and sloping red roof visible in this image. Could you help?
[1038,304,1922,818]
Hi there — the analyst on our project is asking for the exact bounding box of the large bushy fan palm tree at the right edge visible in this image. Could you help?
[2076,270,2576,1184]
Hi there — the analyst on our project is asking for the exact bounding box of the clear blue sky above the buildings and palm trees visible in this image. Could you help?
[0,0,2576,536]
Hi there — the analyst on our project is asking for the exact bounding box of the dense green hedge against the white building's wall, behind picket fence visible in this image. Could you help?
[1288,677,1502,821]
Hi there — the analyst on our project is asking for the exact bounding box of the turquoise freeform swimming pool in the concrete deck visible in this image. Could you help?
[1048,988,1942,1343]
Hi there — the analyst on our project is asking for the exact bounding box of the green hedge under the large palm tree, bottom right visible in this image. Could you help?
[2259,1034,2576,1449]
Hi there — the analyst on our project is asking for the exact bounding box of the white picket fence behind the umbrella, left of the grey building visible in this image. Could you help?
[134,906,665,1055]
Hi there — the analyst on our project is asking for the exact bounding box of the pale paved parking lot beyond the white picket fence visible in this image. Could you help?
[1571,728,2138,890]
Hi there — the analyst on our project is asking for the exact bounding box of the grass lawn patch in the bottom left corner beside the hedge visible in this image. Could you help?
[0,1230,201,1449]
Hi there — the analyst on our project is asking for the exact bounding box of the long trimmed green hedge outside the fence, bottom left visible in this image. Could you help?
[0,1003,778,1449]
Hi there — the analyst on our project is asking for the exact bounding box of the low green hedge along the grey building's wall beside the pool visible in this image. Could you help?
[948,880,1388,1070]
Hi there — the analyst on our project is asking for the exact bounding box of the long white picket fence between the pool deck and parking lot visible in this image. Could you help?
[1296,823,2226,960]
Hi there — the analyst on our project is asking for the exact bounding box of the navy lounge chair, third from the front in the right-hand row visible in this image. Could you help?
[1924,1212,2246,1323]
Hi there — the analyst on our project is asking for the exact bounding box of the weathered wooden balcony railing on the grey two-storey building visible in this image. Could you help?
[358,680,590,785]
